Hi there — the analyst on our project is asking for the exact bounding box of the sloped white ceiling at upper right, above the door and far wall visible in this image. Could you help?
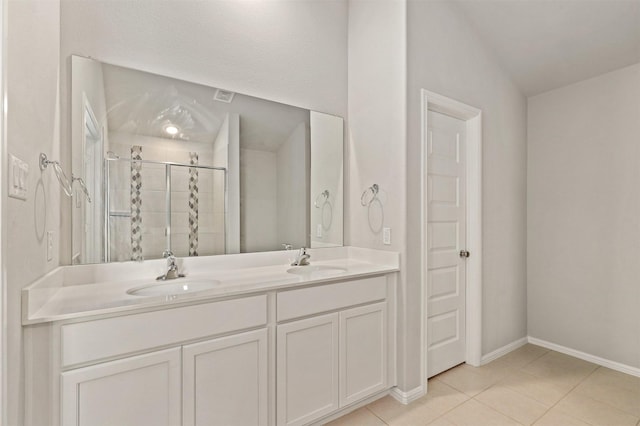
[455,0,640,96]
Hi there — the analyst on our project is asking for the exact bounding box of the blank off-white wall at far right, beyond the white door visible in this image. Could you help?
[527,64,640,368]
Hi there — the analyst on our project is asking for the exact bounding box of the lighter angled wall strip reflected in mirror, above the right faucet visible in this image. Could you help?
[272,123,309,250]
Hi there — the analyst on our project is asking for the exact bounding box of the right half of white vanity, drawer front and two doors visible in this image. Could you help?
[276,277,390,426]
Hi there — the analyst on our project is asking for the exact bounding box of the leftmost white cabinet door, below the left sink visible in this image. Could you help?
[61,348,181,426]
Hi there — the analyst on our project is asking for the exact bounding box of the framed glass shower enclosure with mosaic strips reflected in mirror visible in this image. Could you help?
[103,155,227,262]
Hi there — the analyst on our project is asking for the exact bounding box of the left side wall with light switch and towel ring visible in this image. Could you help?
[2,0,60,425]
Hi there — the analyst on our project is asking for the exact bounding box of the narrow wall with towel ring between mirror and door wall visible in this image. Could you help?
[345,0,410,390]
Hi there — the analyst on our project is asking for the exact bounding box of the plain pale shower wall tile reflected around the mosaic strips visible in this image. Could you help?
[109,136,225,261]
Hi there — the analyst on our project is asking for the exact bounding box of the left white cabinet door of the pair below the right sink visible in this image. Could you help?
[276,314,339,426]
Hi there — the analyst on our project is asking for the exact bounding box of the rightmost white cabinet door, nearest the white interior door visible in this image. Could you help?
[340,303,387,407]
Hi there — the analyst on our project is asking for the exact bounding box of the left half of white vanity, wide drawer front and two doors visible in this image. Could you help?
[53,295,268,426]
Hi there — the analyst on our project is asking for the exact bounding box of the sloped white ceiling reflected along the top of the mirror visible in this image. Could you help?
[102,64,309,152]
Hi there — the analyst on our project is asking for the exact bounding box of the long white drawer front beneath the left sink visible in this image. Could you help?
[61,295,267,367]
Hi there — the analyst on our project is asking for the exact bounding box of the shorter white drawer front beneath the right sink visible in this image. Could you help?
[277,276,387,321]
